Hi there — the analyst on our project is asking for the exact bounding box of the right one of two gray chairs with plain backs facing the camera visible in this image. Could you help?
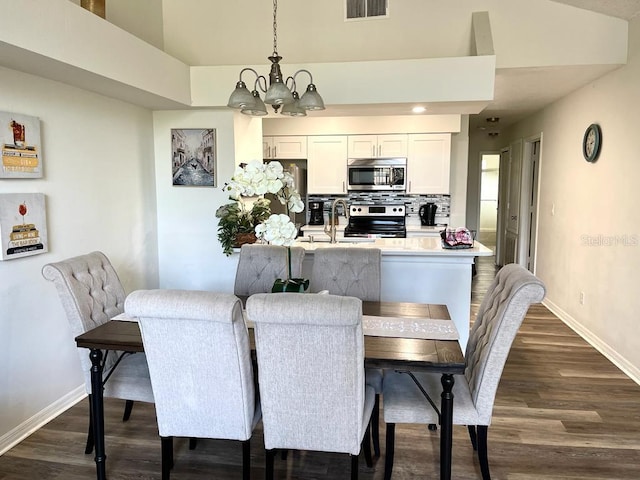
[247,293,374,479]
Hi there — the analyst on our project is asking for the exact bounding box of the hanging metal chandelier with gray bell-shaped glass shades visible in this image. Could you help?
[227,0,324,117]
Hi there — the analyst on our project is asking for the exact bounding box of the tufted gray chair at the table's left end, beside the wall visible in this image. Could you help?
[42,252,153,453]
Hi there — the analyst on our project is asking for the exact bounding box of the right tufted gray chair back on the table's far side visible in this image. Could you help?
[309,247,381,302]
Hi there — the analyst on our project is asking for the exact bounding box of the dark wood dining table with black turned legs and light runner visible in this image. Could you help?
[76,297,465,480]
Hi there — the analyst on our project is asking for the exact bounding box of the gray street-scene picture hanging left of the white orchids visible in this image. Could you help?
[171,128,217,187]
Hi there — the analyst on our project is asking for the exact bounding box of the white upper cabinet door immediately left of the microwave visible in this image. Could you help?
[307,135,347,194]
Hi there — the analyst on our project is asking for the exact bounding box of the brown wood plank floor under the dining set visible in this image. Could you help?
[0,258,640,480]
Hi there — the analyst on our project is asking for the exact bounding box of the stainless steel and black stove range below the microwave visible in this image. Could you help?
[344,204,407,238]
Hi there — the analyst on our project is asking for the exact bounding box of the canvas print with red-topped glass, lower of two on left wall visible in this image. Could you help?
[0,193,49,260]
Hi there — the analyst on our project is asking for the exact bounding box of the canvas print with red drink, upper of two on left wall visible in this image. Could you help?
[0,112,42,178]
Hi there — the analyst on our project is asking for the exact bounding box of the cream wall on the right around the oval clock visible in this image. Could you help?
[506,18,640,381]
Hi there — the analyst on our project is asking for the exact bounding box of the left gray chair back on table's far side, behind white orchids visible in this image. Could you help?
[233,244,304,296]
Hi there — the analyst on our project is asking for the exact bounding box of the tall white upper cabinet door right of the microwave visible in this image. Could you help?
[407,133,451,194]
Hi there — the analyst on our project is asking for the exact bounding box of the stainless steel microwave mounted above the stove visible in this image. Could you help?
[347,157,407,192]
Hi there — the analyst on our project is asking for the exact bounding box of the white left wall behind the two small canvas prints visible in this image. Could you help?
[0,68,157,452]
